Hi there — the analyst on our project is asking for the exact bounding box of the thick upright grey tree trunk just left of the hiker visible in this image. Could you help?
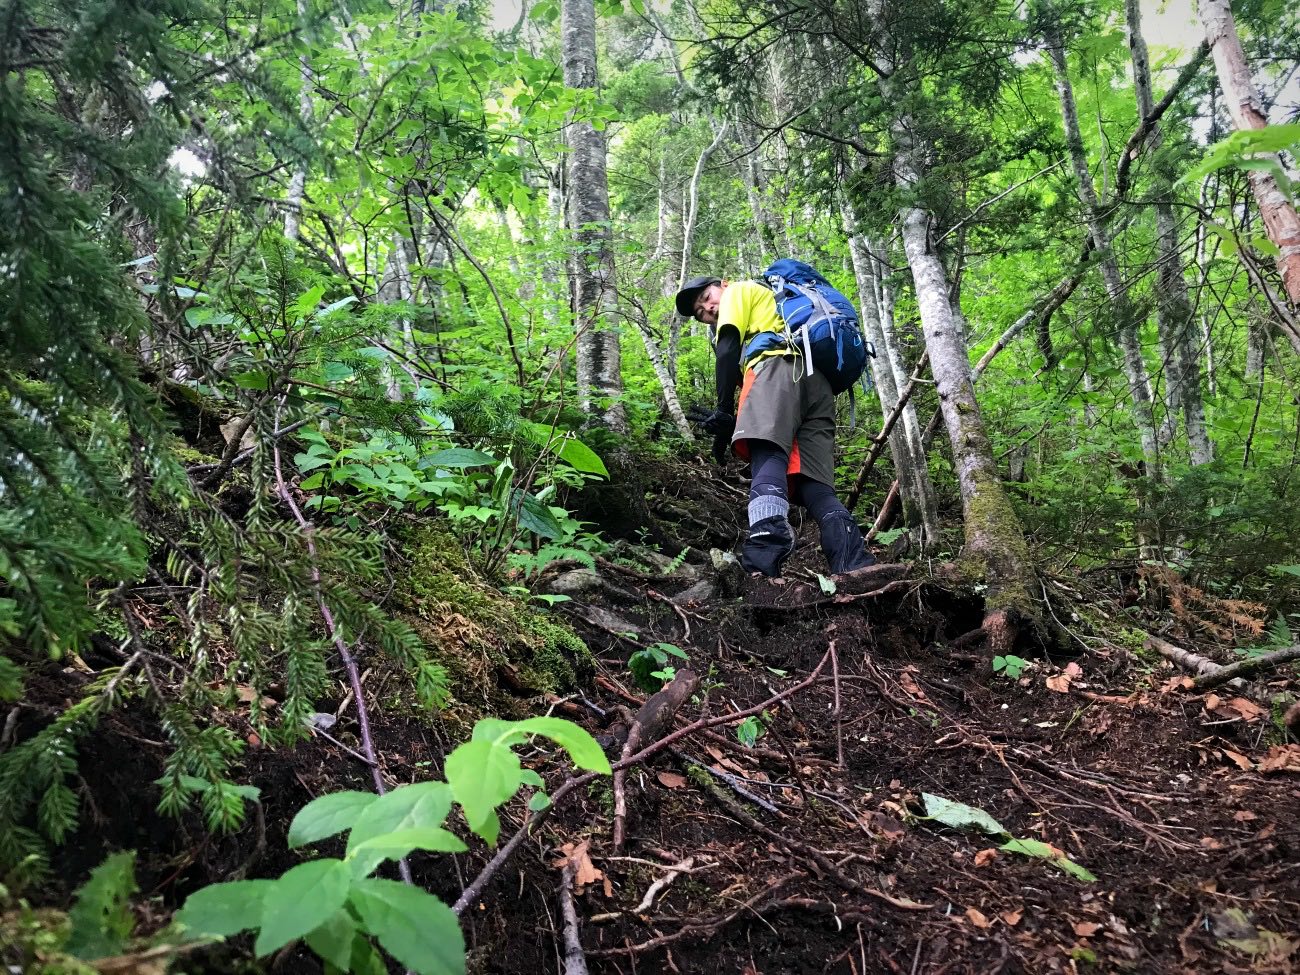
[560,0,627,432]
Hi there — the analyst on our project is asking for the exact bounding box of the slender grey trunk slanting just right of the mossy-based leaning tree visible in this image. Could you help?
[1043,23,1160,477]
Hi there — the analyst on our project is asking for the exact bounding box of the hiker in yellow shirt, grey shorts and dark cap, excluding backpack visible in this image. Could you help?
[677,276,875,576]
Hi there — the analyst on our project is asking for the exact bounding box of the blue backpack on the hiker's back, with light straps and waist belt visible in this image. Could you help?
[742,257,876,394]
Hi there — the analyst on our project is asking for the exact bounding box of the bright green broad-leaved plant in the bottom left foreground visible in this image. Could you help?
[177,718,610,975]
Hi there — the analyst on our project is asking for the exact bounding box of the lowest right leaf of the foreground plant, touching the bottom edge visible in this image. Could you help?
[350,878,465,975]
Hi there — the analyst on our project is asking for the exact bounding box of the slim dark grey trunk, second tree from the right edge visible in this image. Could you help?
[1125,0,1214,465]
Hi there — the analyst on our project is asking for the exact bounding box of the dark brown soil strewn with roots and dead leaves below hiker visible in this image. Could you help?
[30,457,1300,975]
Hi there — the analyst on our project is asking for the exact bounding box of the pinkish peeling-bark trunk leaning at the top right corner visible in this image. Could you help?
[1196,0,1300,306]
